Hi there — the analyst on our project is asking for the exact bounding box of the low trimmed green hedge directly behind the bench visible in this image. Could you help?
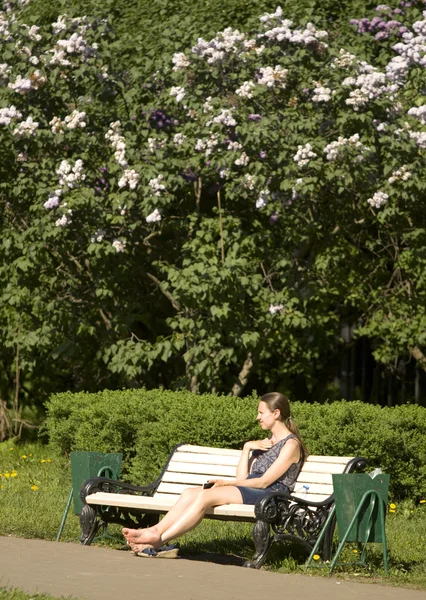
[45,389,426,500]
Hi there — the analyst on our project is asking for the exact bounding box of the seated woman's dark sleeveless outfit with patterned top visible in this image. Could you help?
[236,433,304,504]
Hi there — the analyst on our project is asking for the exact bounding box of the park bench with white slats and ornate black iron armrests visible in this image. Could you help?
[80,444,367,568]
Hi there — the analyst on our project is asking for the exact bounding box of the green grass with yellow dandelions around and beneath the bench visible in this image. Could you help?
[0,442,426,600]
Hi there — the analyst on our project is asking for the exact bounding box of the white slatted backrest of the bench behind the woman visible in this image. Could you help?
[154,445,353,502]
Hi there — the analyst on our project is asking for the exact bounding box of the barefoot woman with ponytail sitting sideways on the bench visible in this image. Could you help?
[123,392,307,556]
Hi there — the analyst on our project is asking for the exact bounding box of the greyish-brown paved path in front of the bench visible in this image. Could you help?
[0,537,426,600]
